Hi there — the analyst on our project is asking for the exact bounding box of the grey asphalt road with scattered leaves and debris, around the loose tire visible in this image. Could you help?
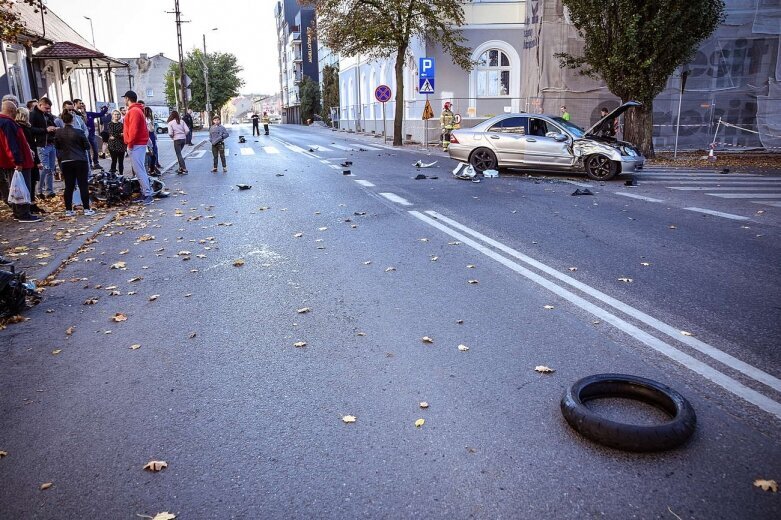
[0,126,781,519]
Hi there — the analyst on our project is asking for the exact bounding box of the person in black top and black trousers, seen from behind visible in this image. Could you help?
[54,110,95,217]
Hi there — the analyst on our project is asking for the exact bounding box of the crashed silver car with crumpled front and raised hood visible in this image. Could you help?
[448,101,645,181]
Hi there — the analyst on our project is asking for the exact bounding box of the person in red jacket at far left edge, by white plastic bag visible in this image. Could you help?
[0,95,40,222]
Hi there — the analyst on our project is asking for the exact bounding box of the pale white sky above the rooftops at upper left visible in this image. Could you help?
[46,0,279,94]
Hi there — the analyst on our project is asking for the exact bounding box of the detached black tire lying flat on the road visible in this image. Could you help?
[561,374,697,452]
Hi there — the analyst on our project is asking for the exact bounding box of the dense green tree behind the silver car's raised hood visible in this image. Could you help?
[556,0,724,157]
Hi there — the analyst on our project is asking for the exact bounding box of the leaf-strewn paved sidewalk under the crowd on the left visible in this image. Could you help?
[0,131,209,281]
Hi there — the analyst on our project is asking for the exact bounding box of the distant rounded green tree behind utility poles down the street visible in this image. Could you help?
[165,49,244,112]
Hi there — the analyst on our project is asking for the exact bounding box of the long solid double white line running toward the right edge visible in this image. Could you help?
[410,211,781,418]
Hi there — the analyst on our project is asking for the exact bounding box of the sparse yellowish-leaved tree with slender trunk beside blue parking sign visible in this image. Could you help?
[306,0,473,146]
